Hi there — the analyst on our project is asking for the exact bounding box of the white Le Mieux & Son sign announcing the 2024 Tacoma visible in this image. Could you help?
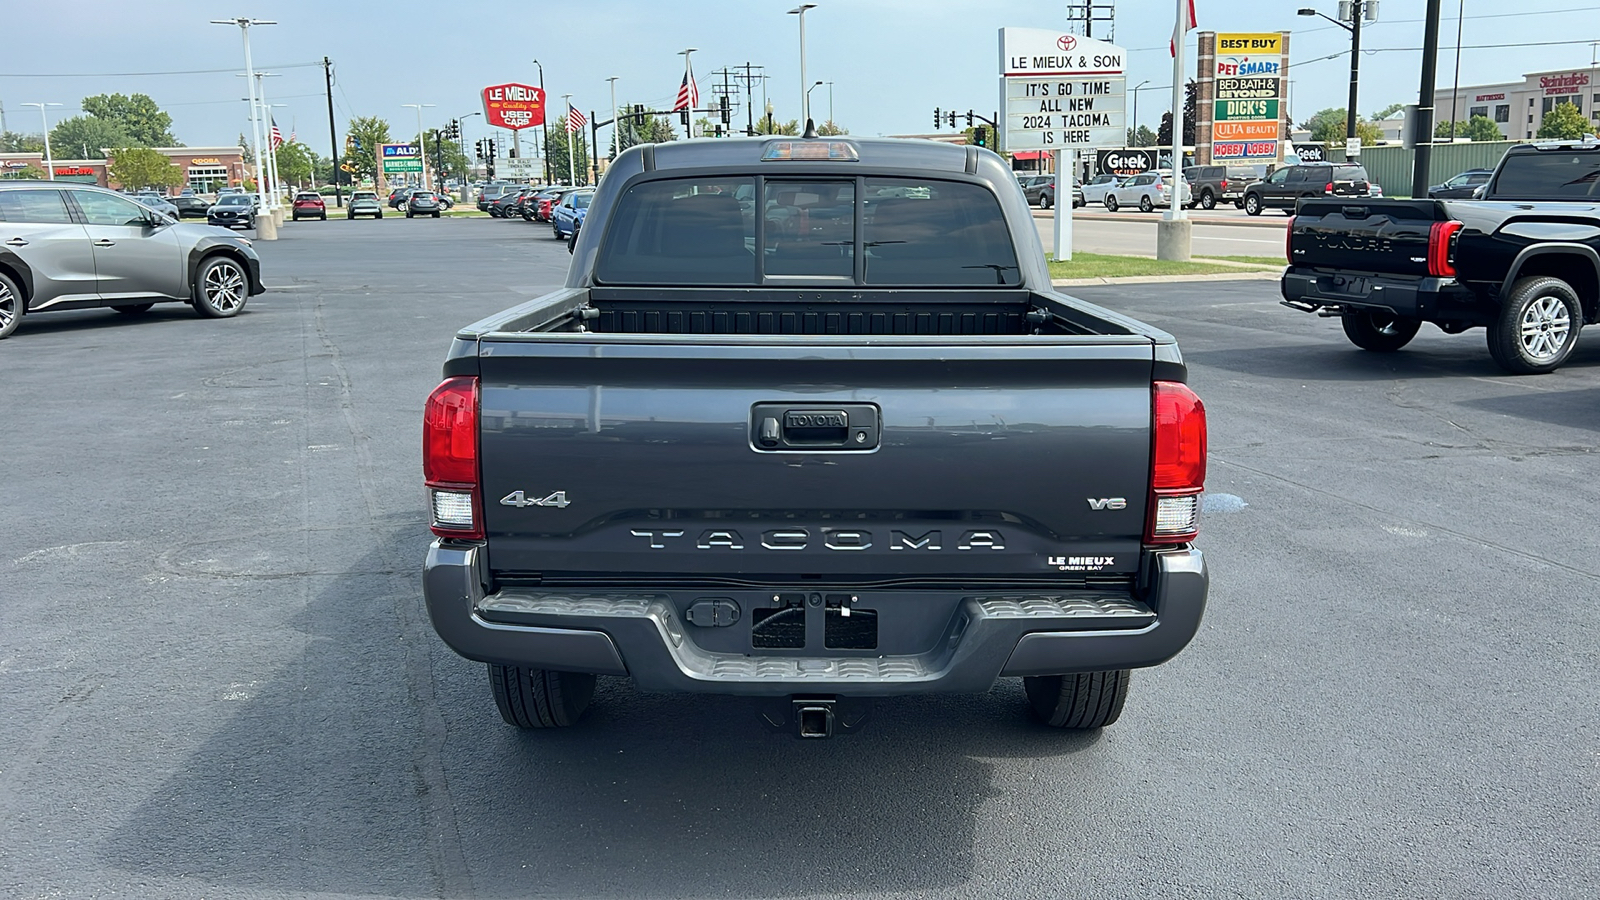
[1000,29,1128,151]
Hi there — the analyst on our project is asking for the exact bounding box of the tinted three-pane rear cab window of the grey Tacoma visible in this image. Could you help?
[594,175,1021,287]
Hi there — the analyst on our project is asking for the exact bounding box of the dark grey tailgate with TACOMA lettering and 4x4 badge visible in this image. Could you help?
[478,333,1154,583]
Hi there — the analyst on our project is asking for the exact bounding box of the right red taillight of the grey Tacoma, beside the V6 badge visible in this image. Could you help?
[1144,381,1206,543]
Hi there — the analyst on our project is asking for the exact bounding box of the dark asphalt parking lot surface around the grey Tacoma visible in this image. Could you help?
[0,216,1600,900]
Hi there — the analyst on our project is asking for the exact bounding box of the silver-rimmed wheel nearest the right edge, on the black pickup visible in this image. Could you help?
[1488,275,1584,375]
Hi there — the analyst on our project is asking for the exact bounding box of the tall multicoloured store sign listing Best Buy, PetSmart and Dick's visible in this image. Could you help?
[1211,32,1283,162]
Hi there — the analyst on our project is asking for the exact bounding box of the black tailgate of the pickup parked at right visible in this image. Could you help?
[1288,197,1446,275]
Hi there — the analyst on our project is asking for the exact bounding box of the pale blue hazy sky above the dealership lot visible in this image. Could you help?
[0,0,1600,152]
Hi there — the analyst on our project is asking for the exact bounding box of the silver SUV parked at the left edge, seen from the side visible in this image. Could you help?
[0,181,266,338]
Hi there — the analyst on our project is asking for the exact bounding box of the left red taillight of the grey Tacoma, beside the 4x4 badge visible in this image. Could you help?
[422,376,483,538]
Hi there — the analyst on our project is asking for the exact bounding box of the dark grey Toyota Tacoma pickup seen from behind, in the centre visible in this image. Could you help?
[424,138,1208,737]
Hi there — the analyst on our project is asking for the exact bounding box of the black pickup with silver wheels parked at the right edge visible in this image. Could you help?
[1282,141,1600,375]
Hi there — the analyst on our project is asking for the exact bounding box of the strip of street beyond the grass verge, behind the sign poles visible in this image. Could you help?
[1034,210,1288,258]
